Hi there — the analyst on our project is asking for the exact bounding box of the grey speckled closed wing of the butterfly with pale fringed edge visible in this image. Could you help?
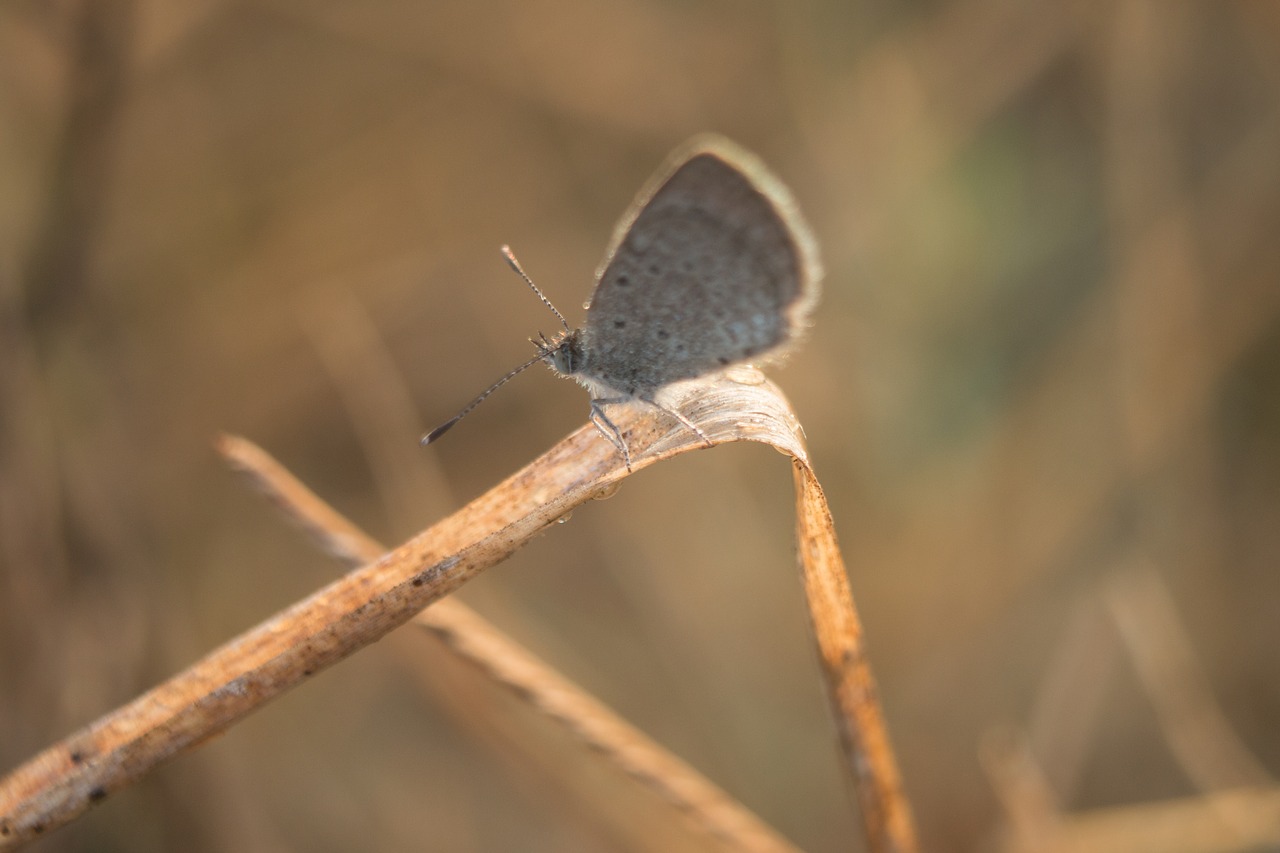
[581,137,820,396]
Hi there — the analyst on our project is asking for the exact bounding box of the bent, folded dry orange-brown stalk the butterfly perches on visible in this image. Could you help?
[0,370,915,850]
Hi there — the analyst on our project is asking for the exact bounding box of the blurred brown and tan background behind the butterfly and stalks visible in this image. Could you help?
[0,0,1280,850]
